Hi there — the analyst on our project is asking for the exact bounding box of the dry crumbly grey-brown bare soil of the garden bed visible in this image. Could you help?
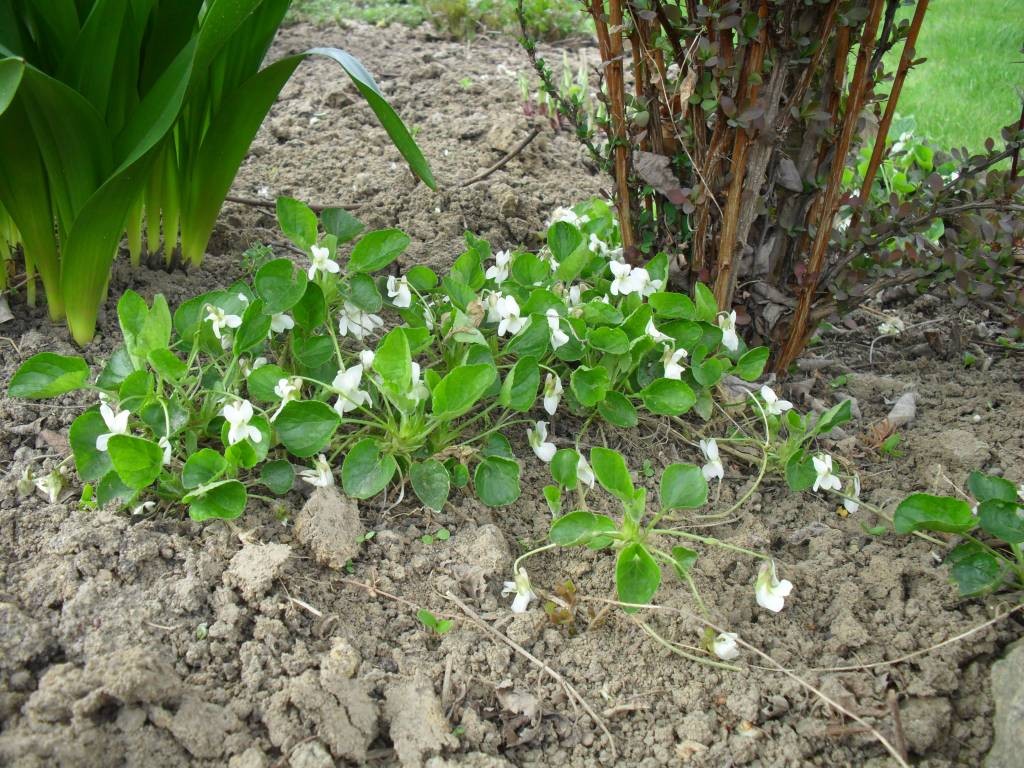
[0,18,1024,768]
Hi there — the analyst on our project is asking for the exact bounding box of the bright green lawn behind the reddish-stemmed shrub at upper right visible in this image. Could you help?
[887,0,1024,151]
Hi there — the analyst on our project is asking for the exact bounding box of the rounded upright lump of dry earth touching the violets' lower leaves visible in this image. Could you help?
[295,485,364,570]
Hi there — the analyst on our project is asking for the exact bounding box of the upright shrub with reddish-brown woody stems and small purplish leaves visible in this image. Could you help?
[519,0,1024,371]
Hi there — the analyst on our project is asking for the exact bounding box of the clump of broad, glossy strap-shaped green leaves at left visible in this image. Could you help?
[0,0,433,344]
